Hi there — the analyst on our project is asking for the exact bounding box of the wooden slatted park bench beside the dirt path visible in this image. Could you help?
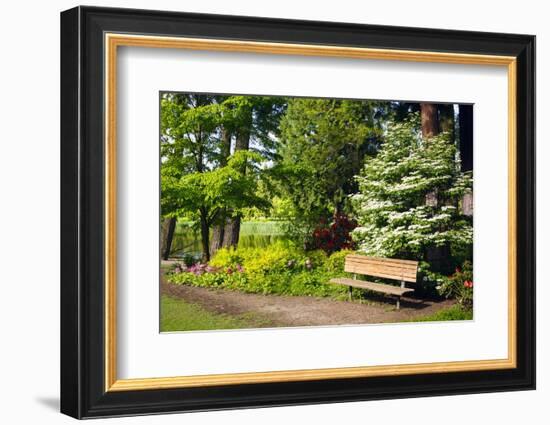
[330,254,418,309]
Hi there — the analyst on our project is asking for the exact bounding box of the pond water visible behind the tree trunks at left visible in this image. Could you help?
[170,221,285,258]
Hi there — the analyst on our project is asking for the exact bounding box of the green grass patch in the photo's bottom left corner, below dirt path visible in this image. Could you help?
[160,295,270,332]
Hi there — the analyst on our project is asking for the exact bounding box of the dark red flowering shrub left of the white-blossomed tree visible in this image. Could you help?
[308,214,357,255]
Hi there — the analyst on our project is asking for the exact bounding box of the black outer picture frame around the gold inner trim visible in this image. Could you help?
[61,7,535,418]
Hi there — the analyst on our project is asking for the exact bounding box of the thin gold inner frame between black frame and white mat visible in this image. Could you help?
[104,33,517,391]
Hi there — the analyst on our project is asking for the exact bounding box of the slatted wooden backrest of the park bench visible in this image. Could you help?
[344,254,418,283]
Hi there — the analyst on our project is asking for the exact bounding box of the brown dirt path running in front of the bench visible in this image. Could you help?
[161,276,453,327]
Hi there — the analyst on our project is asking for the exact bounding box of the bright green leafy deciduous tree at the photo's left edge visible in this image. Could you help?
[161,93,281,261]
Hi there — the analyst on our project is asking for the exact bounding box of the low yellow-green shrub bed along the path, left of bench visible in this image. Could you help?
[168,242,349,299]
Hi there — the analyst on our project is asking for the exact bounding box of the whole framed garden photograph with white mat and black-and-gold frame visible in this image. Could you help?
[61,7,535,418]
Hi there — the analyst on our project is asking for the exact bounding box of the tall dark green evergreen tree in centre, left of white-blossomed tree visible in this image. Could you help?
[275,98,389,242]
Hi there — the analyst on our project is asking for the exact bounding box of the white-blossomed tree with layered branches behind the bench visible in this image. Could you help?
[352,114,473,271]
